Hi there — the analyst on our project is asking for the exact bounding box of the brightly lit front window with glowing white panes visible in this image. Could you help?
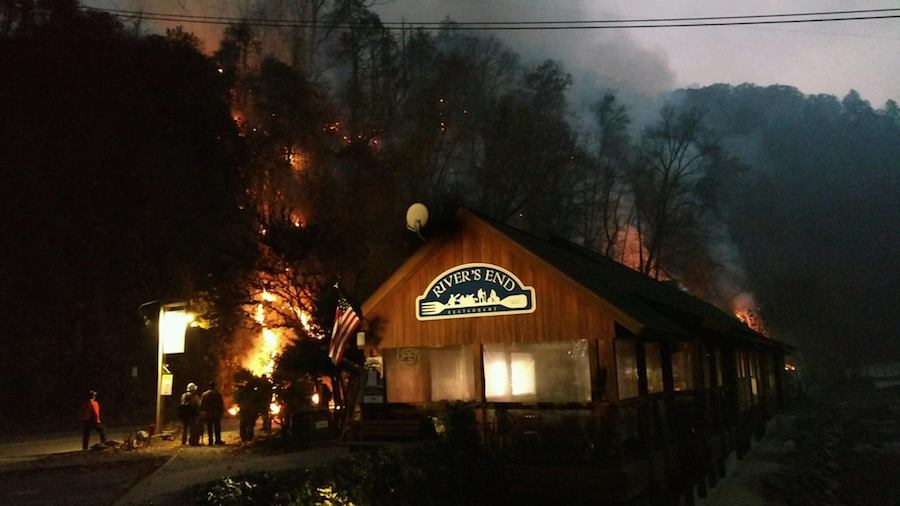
[484,339,591,402]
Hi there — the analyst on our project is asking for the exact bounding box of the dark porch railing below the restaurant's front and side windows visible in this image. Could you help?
[364,387,766,465]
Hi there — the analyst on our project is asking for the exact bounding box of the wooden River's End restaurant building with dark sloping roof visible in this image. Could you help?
[362,210,787,502]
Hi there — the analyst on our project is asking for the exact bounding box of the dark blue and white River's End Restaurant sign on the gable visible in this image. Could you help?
[416,263,535,320]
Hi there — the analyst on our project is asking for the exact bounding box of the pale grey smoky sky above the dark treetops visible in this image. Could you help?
[93,0,900,109]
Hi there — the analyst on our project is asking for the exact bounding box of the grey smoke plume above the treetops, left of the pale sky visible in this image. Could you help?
[376,0,676,131]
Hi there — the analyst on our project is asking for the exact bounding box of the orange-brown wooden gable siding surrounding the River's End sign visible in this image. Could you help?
[363,215,620,350]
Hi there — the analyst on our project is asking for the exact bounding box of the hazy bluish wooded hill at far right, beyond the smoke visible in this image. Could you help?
[674,84,900,374]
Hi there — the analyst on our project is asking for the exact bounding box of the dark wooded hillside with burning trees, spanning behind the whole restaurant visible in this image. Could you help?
[0,0,900,431]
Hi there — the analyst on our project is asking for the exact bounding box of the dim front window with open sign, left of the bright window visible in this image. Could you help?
[384,346,475,403]
